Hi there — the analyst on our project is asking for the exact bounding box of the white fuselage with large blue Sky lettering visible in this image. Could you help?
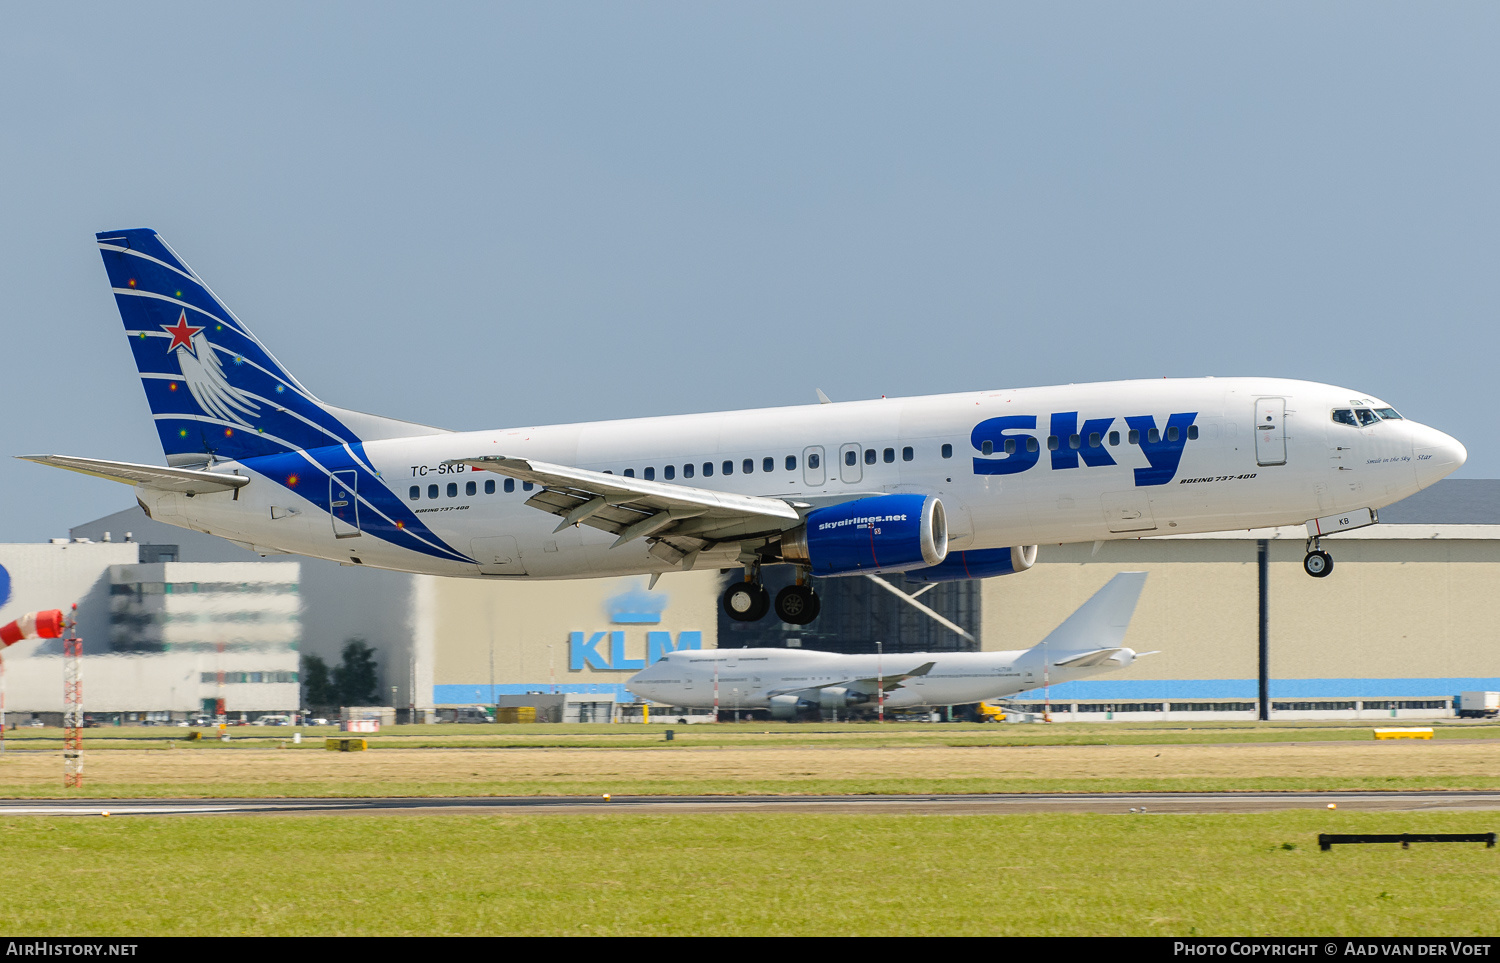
[137,378,1467,579]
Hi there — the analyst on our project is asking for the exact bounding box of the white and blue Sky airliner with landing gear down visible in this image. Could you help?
[26,228,1467,624]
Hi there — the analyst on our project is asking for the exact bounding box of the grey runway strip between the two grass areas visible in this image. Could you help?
[0,791,1500,816]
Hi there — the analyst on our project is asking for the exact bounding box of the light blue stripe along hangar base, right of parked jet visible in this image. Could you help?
[1025,677,1500,701]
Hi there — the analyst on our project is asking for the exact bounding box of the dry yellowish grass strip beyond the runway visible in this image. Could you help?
[0,723,1500,798]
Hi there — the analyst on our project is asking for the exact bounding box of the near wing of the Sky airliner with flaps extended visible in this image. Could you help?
[444,455,809,569]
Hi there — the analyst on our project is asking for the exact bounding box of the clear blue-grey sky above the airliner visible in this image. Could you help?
[0,3,1500,542]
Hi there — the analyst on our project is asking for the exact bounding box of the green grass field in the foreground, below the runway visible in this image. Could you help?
[0,812,1500,936]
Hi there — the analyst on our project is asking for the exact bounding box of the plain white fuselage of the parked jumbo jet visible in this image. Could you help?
[629,648,1134,710]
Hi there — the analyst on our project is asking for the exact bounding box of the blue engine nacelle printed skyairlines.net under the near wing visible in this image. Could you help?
[782,494,948,576]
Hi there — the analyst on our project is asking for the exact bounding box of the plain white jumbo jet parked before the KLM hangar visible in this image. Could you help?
[626,572,1152,719]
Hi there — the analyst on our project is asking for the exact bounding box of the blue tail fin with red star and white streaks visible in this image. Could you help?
[96,228,438,465]
